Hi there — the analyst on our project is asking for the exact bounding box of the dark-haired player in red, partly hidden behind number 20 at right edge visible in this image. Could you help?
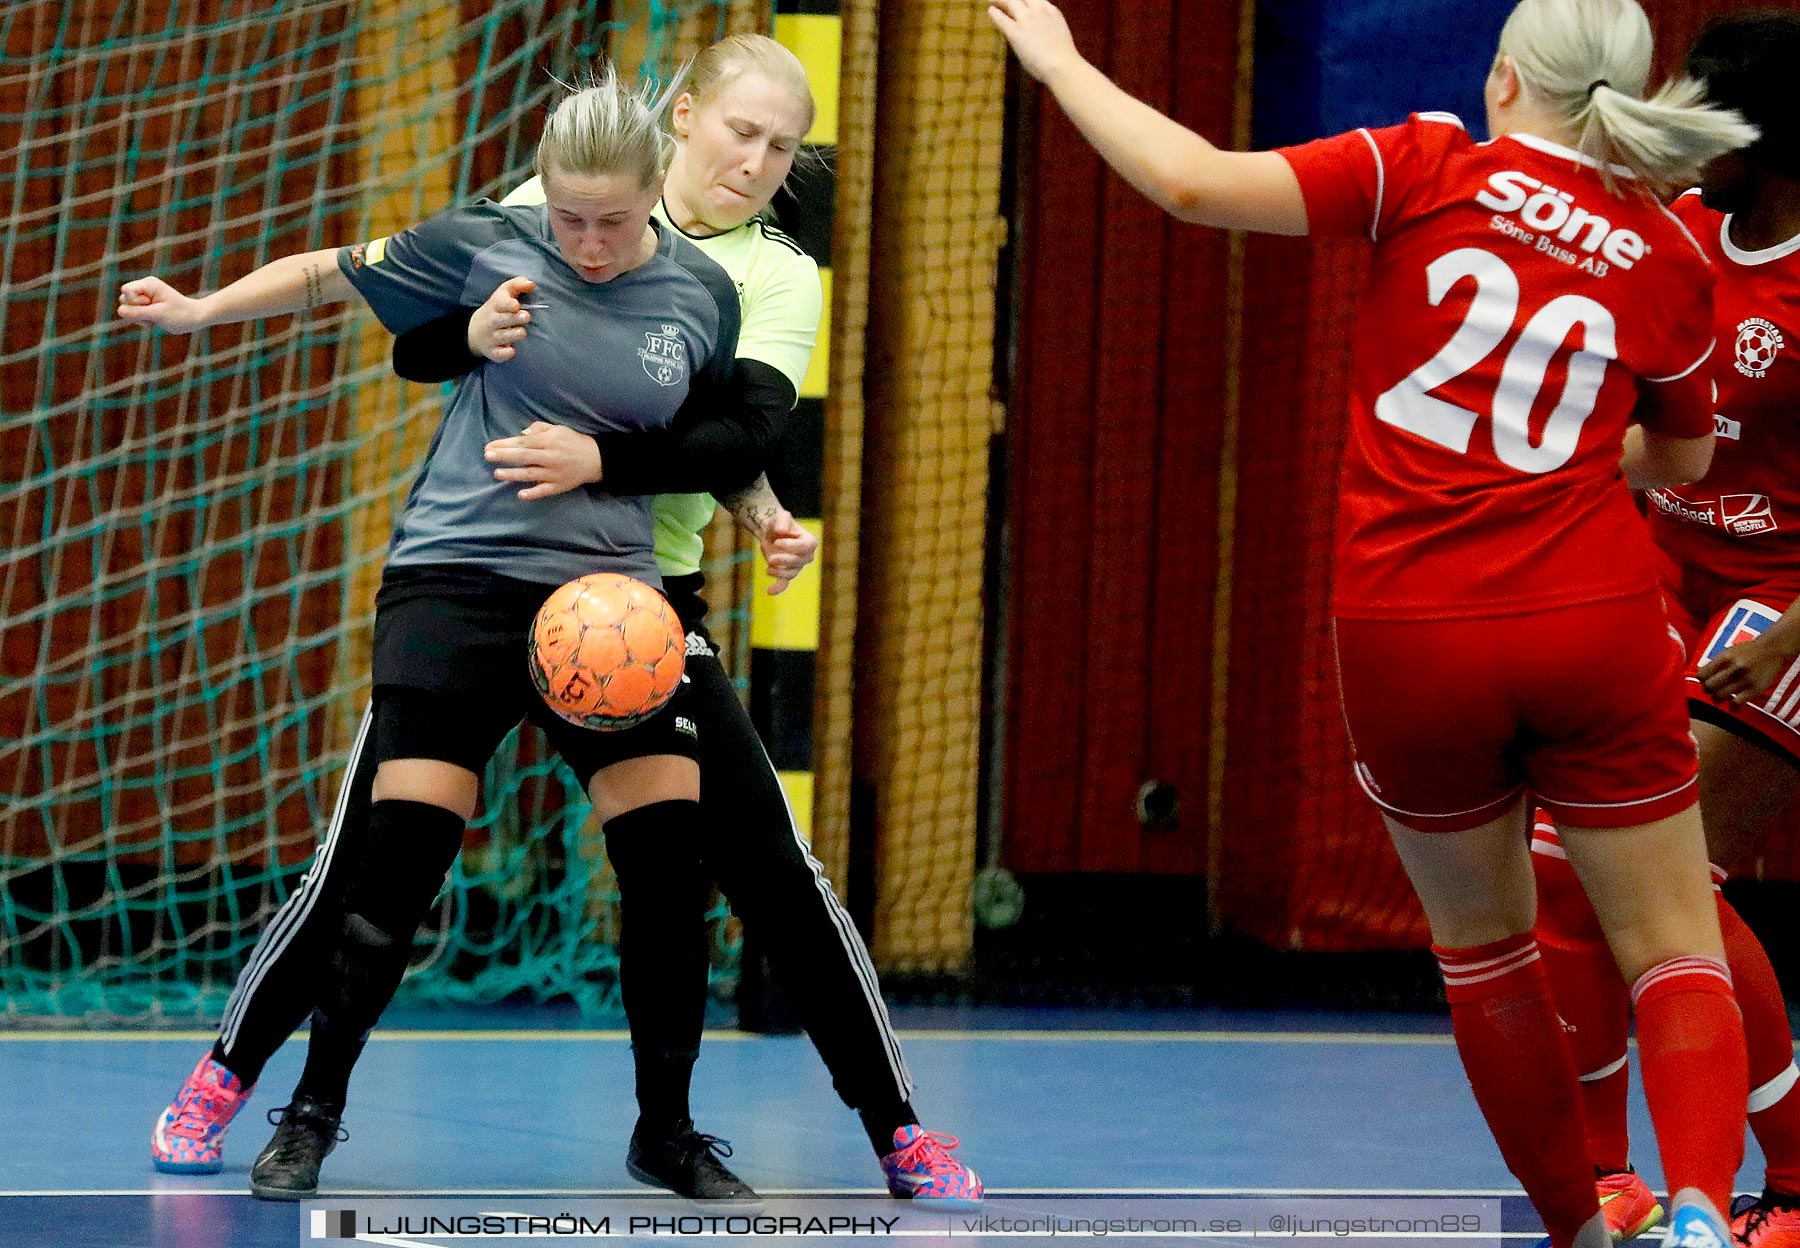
[1532,13,1800,1248]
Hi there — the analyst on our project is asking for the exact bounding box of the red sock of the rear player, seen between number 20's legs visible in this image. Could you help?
[1532,810,1631,1171]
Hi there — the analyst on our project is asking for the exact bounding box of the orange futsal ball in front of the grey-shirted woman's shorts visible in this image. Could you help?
[527,573,688,731]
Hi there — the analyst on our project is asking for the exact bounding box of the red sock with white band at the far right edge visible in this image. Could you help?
[1719,895,1800,1196]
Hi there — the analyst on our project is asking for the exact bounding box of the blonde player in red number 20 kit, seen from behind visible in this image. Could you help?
[988,0,1755,1248]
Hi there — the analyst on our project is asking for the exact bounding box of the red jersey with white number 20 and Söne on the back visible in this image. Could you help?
[1282,113,1714,619]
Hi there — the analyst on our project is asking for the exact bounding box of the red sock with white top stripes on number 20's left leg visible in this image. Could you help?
[1433,933,1600,1248]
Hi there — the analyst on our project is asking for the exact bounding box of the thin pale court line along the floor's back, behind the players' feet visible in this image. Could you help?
[0,1030,1456,1046]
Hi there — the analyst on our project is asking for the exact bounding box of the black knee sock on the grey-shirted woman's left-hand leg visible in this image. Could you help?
[295,800,463,1109]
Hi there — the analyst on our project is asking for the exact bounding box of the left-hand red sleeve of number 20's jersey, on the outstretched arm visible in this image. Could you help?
[1276,113,1469,240]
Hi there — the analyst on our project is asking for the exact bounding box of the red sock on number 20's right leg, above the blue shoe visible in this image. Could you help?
[1631,958,1750,1210]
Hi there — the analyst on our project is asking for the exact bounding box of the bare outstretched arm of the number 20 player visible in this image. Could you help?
[988,0,1307,234]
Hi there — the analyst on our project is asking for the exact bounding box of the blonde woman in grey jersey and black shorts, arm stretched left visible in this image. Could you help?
[119,70,742,1199]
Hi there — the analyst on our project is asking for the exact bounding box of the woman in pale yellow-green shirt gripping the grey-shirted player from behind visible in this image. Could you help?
[140,36,979,1199]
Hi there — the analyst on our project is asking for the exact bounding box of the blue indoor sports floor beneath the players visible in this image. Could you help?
[0,1008,1762,1248]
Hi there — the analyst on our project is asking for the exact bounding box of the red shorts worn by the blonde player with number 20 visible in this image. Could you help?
[1334,592,1699,832]
